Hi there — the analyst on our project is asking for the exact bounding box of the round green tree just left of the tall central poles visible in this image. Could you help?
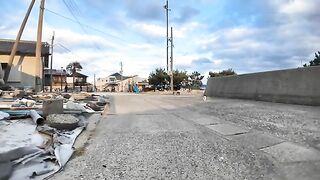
[148,68,169,89]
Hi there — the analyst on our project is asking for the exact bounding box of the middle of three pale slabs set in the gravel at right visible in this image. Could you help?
[229,133,284,149]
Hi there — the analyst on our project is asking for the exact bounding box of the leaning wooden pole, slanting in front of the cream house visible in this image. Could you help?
[3,0,35,83]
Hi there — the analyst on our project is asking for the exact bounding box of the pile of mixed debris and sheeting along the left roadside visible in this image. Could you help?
[0,91,109,180]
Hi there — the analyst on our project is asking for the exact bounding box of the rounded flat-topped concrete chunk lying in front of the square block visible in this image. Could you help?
[45,114,79,130]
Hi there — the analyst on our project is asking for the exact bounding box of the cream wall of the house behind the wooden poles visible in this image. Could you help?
[0,55,42,88]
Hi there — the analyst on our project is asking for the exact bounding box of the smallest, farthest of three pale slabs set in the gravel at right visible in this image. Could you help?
[207,124,248,136]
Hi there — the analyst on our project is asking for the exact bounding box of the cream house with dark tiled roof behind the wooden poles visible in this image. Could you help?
[0,39,50,89]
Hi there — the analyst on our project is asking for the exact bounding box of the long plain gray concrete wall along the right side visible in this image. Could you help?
[205,66,320,106]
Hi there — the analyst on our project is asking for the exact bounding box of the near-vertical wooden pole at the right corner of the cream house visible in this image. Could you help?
[35,0,45,91]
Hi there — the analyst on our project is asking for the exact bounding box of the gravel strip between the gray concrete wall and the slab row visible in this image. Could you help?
[195,98,320,150]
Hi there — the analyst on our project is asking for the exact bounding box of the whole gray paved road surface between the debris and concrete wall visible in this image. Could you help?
[53,94,320,179]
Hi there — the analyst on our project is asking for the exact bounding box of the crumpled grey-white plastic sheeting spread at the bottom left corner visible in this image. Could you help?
[0,119,84,180]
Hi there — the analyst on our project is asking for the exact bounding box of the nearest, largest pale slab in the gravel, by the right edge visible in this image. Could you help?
[261,142,320,163]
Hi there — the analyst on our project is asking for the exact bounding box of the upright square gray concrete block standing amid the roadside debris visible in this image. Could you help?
[42,99,63,116]
